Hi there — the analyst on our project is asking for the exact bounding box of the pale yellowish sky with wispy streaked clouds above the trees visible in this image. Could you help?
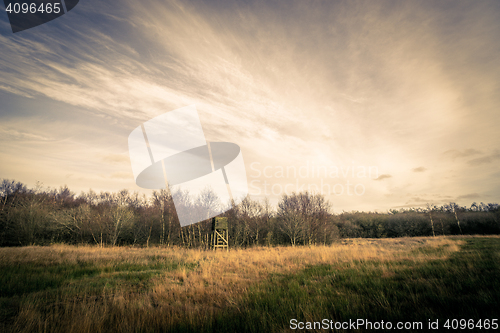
[0,0,500,212]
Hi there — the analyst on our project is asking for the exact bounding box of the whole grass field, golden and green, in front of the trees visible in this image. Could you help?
[0,237,500,332]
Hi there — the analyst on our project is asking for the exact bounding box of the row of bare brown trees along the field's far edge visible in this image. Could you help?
[0,179,500,248]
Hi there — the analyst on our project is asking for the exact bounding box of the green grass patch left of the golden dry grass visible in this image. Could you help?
[0,252,197,331]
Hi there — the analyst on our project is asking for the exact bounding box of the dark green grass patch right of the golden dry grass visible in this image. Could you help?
[199,238,500,332]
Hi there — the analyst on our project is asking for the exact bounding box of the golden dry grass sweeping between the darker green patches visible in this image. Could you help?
[0,237,461,332]
